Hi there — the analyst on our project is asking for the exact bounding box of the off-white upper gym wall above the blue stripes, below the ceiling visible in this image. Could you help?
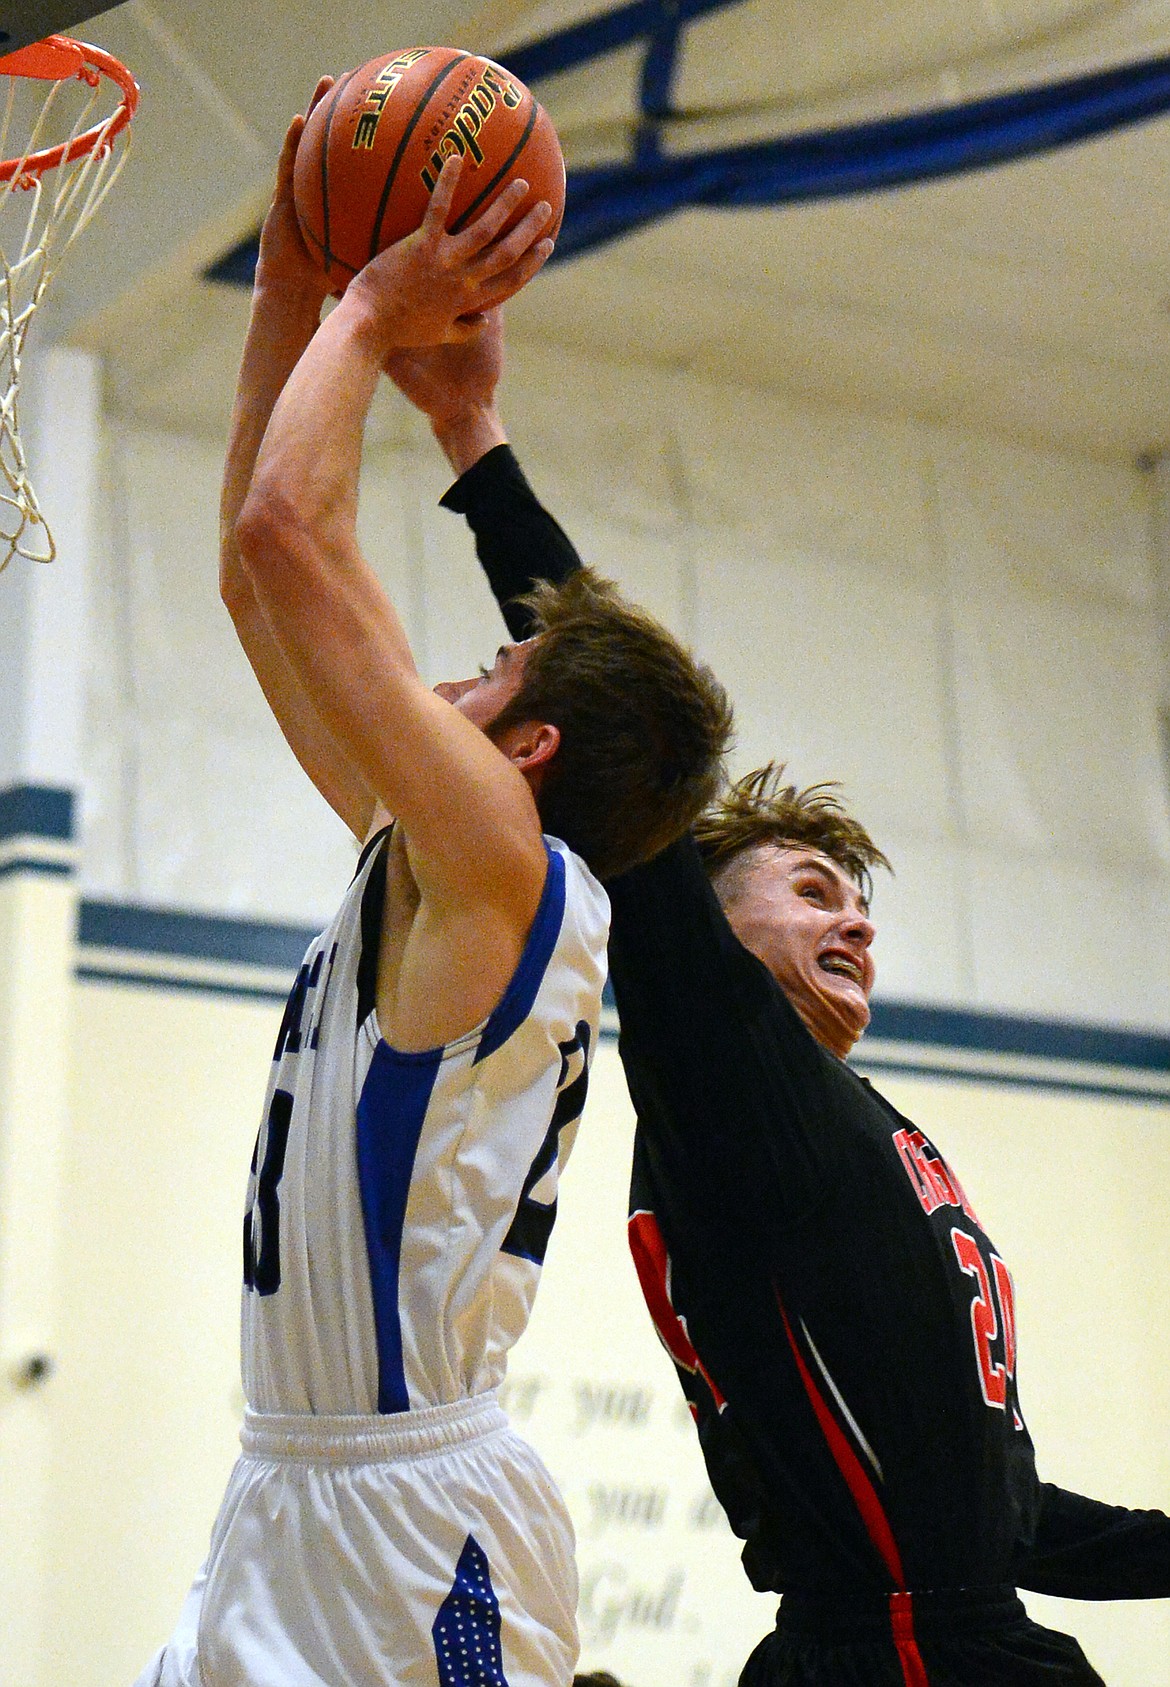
[83,342,1170,1029]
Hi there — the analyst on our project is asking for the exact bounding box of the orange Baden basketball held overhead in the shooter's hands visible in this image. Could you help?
[293,47,565,288]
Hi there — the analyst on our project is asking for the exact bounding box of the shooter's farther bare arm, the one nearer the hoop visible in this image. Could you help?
[219,78,374,837]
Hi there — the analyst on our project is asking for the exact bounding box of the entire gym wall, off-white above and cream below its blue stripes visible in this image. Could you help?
[0,332,1170,1687]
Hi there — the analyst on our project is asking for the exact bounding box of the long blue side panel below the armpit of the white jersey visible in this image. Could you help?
[357,1043,443,1412]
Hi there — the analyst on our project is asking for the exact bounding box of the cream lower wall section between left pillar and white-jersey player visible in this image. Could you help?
[43,984,269,1687]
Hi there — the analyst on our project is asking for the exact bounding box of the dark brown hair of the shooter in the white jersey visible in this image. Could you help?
[489,569,732,879]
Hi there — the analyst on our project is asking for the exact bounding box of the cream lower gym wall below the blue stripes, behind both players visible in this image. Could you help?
[16,951,1170,1687]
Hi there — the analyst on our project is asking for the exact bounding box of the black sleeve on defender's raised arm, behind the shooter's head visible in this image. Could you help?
[442,445,836,1241]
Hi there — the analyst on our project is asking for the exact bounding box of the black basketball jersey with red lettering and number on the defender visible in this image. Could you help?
[610,838,1039,1591]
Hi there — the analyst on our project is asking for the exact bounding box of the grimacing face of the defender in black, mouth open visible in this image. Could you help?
[723,844,875,1059]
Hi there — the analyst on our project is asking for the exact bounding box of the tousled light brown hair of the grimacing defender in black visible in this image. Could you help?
[695,761,894,903]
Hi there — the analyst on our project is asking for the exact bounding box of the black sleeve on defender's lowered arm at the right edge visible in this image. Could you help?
[1015,1483,1170,1599]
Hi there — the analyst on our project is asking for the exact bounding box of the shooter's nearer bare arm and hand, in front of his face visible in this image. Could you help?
[236,164,556,919]
